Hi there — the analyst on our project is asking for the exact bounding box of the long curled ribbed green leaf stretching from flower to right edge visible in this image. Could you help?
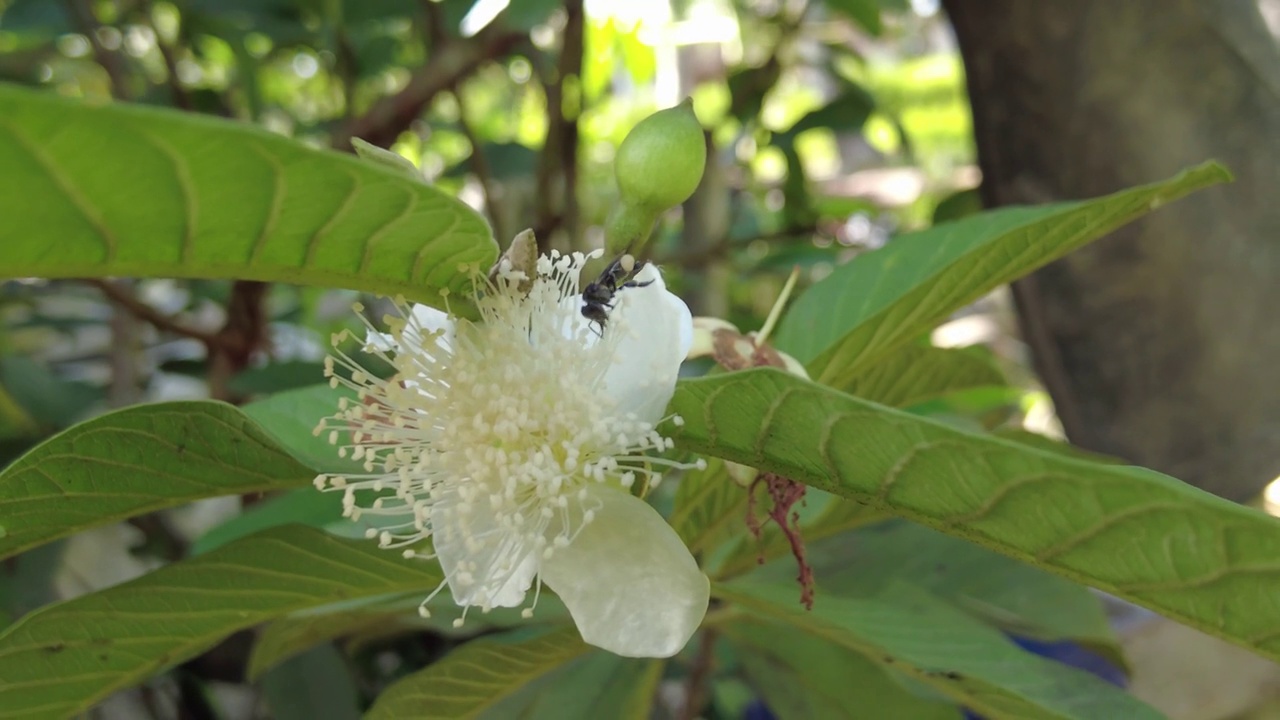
[668,368,1280,660]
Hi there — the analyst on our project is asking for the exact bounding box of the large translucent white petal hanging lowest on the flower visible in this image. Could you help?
[541,486,710,657]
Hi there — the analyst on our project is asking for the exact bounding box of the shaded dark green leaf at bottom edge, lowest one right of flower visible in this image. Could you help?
[721,619,960,720]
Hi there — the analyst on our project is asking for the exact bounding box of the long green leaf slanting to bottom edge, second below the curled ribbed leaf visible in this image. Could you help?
[712,579,1161,720]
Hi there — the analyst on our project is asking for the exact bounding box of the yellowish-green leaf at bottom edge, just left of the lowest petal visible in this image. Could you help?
[365,625,590,720]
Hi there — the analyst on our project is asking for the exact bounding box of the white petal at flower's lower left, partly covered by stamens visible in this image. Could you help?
[431,503,538,607]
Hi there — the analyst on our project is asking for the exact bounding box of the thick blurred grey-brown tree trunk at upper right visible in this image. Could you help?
[943,0,1280,500]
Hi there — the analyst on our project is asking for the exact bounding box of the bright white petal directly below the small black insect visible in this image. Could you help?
[604,264,694,423]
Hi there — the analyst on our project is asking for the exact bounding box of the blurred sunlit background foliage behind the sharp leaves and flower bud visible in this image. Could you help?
[0,0,1269,719]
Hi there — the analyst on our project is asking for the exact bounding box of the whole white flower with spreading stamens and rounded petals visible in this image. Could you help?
[316,248,709,657]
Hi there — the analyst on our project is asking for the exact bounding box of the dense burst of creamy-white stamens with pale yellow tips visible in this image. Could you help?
[316,254,691,611]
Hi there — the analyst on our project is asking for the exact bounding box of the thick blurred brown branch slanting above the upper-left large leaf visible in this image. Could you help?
[333,20,525,151]
